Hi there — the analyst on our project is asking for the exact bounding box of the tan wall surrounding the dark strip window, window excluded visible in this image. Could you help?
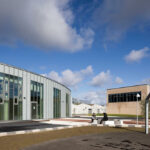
[106,85,150,115]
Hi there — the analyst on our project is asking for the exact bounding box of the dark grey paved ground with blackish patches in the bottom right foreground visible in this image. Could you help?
[24,129,150,150]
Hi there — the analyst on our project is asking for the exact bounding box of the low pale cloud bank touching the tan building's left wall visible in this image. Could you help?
[79,91,106,105]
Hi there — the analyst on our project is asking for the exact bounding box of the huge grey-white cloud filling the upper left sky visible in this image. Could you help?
[0,0,94,52]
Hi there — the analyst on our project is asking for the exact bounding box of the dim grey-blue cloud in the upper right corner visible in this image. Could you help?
[94,0,150,42]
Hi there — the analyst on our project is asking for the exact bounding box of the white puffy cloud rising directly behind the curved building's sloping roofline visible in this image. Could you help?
[44,66,93,87]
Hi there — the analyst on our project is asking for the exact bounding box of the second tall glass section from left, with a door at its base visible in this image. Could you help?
[31,81,43,119]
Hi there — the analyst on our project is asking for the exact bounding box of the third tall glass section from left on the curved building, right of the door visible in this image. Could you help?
[53,88,61,118]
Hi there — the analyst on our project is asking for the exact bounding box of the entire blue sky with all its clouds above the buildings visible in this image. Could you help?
[0,0,150,105]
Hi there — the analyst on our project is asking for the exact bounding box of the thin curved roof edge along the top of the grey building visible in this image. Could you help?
[0,62,71,91]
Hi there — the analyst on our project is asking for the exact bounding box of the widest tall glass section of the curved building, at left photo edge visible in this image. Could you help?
[0,73,22,120]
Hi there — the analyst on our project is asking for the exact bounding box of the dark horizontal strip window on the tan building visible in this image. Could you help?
[108,92,141,103]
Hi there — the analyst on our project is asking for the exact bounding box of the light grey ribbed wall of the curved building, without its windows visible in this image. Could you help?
[0,63,72,120]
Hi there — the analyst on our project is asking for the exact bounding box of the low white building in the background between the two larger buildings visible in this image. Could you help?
[72,103,105,115]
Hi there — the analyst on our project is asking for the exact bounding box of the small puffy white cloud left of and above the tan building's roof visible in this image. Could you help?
[91,70,112,87]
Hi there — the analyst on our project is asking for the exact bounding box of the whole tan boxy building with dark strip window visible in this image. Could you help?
[106,84,150,115]
